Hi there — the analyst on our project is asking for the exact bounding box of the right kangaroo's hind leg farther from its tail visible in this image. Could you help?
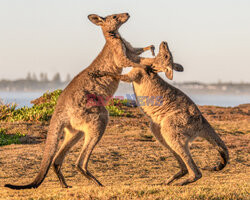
[150,123,188,185]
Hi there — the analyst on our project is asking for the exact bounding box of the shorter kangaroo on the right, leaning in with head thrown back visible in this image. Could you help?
[94,42,229,185]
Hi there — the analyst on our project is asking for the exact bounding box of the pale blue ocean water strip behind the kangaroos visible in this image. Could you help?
[0,89,250,107]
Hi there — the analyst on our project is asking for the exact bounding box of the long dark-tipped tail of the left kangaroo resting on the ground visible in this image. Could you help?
[4,114,63,190]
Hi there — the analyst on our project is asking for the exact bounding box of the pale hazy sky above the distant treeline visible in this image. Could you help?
[0,0,250,82]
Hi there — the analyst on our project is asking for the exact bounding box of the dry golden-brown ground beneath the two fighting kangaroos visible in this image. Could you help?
[0,104,250,199]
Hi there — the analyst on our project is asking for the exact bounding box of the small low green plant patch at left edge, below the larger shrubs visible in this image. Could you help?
[0,128,25,146]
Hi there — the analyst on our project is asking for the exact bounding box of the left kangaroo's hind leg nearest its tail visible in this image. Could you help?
[52,127,83,188]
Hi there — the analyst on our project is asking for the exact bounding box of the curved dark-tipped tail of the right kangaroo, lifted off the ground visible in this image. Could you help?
[202,119,229,171]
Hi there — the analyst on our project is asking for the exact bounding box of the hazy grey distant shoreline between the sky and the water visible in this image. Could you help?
[0,79,250,95]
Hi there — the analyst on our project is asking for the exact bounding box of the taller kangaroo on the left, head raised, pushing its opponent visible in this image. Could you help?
[5,13,157,189]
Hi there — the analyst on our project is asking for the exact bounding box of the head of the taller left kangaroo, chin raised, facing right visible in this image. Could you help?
[88,13,129,32]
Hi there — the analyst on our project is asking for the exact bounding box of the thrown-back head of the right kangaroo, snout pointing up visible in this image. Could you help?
[153,42,183,80]
